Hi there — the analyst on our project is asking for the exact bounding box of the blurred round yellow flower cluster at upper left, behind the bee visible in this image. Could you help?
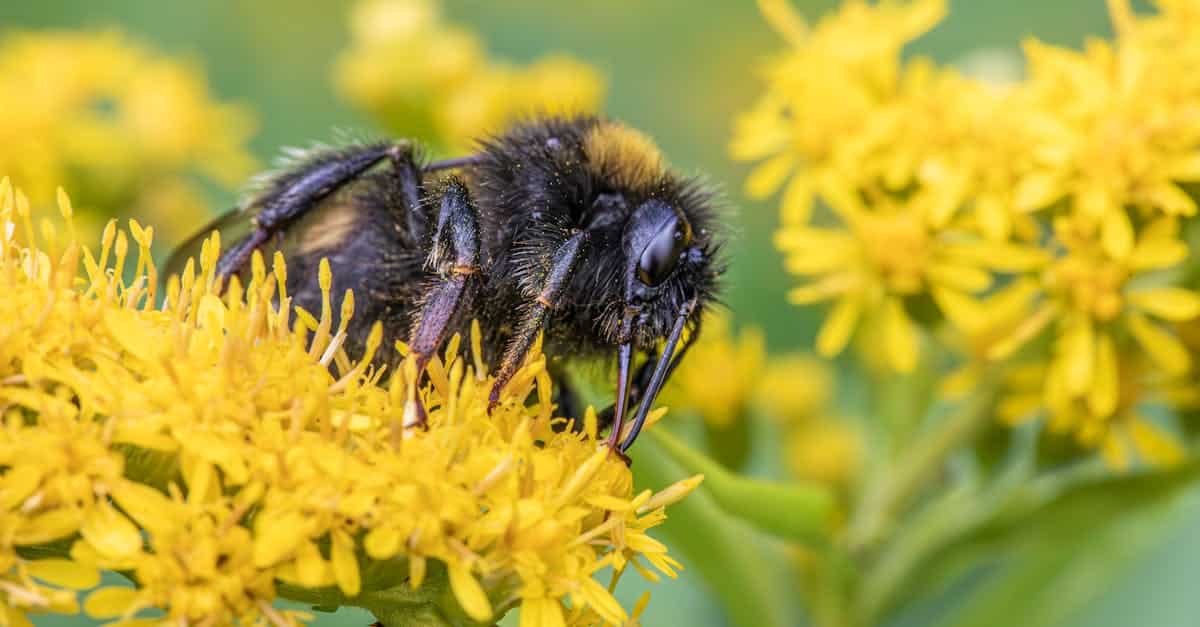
[0,31,256,248]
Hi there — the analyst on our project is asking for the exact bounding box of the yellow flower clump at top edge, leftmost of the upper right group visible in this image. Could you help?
[731,0,946,223]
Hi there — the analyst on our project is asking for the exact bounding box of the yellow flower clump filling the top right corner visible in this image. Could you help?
[1014,0,1200,246]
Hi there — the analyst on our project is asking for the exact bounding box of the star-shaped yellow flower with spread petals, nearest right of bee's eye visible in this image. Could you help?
[775,196,1040,372]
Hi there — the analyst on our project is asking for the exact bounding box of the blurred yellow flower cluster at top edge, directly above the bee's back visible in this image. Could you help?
[335,0,605,153]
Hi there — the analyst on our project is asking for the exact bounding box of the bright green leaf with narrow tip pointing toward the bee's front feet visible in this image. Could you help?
[638,429,835,547]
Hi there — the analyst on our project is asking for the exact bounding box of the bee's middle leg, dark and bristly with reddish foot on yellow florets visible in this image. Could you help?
[406,178,480,426]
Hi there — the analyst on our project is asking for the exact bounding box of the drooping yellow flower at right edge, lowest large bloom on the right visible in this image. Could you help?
[946,217,1200,467]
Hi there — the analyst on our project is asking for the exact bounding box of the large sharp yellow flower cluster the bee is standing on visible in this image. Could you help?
[0,179,700,627]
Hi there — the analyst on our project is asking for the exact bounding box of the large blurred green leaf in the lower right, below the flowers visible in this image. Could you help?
[890,464,1200,627]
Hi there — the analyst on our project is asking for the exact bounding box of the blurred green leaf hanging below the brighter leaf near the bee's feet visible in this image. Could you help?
[634,426,802,627]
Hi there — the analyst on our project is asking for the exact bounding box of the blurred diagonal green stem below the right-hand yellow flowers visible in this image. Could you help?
[846,378,996,554]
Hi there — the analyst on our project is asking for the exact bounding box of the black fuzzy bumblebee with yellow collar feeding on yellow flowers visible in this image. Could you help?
[170,117,724,460]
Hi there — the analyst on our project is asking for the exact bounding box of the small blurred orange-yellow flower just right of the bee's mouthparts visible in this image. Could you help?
[662,311,767,426]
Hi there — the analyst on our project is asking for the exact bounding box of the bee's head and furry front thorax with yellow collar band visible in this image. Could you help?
[475,117,724,449]
